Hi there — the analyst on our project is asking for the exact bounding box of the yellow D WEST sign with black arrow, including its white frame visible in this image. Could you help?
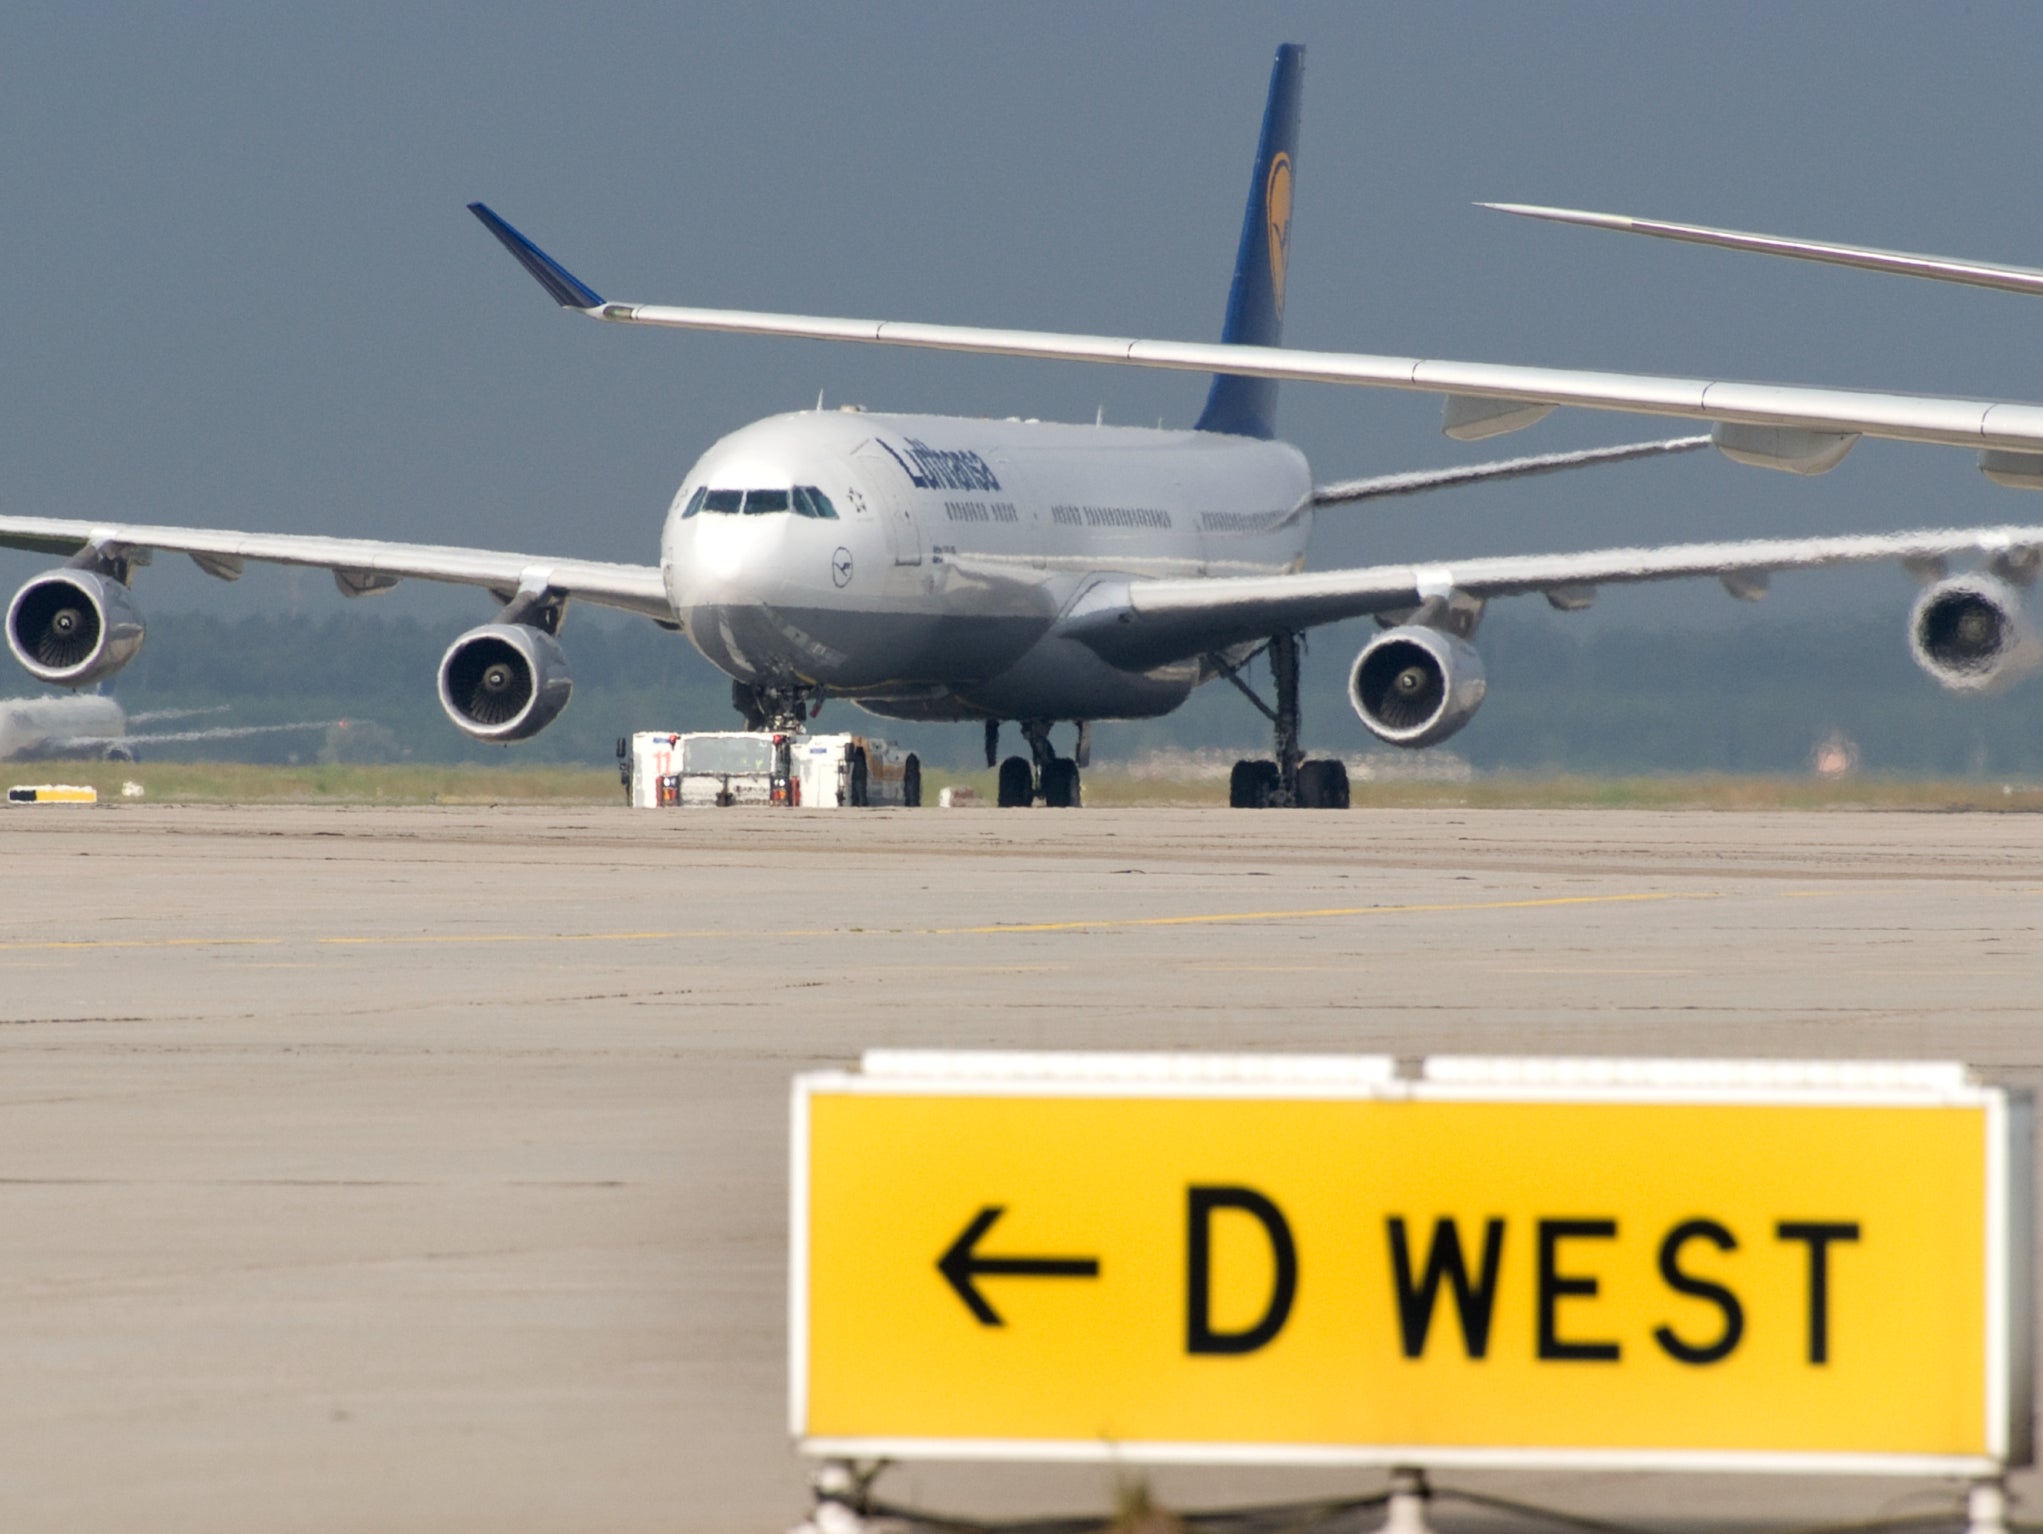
[791,1054,2031,1473]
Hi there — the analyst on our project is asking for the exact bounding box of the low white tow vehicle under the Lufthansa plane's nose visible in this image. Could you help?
[617,729,921,809]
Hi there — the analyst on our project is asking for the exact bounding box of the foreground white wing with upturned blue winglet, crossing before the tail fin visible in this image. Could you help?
[470,202,2043,488]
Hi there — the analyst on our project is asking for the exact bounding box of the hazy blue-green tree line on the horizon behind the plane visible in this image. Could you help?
[63,607,2043,776]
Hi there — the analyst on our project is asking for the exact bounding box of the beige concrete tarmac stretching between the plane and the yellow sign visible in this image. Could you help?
[0,805,2043,1534]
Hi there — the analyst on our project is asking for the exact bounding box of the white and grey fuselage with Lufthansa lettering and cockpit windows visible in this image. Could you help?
[660,411,1312,719]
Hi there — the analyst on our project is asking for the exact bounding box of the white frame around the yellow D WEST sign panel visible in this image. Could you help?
[789,1050,2035,1479]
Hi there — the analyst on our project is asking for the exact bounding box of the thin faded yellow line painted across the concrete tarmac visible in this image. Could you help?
[0,891,1722,954]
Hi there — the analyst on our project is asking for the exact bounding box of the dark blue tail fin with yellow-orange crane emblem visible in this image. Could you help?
[1199,43,1305,437]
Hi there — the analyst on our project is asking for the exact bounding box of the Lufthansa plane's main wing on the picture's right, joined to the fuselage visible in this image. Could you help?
[1060,527,2043,668]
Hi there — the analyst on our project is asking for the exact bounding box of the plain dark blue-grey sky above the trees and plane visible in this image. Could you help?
[0,2,2043,627]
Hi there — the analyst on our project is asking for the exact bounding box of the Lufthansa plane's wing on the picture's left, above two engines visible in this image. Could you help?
[0,517,674,623]
